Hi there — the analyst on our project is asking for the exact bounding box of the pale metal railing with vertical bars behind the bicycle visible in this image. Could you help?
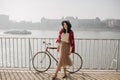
[0,37,120,70]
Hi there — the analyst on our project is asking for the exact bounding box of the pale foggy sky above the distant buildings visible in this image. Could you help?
[0,0,120,22]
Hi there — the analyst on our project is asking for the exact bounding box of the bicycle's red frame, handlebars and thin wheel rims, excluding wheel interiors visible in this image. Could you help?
[32,42,83,73]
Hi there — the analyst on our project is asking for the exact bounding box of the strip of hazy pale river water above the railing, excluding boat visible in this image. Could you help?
[0,30,120,39]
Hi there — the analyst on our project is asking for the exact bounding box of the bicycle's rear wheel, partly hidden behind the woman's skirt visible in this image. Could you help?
[66,53,83,73]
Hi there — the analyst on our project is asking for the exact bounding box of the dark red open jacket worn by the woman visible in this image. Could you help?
[56,29,75,52]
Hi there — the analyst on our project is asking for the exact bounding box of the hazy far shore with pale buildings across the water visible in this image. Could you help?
[0,15,120,30]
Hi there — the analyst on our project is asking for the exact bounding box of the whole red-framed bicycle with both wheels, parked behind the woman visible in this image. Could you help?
[32,41,83,73]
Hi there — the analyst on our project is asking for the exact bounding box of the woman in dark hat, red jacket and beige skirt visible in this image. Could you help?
[52,21,75,80]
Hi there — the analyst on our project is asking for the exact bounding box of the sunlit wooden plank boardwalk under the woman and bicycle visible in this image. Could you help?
[0,69,120,80]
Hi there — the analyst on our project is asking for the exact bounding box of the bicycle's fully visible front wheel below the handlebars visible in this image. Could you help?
[32,51,51,72]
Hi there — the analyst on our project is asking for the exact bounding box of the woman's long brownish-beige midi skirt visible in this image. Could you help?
[58,42,72,67]
